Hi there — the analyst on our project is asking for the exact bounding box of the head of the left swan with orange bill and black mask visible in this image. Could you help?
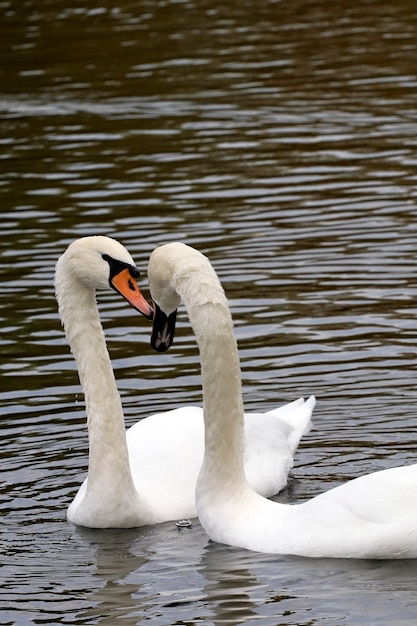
[55,235,153,319]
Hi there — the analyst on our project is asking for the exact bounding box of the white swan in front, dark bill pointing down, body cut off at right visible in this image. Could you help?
[148,243,417,559]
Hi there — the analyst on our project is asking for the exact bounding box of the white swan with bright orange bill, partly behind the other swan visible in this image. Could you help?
[55,236,314,528]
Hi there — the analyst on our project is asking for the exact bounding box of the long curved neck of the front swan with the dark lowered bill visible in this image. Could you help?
[175,266,245,490]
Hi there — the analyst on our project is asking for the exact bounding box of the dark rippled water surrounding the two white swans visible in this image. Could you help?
[0,0,417,626]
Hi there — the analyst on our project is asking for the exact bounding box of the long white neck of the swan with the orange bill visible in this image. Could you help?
[56,273,134,493]
